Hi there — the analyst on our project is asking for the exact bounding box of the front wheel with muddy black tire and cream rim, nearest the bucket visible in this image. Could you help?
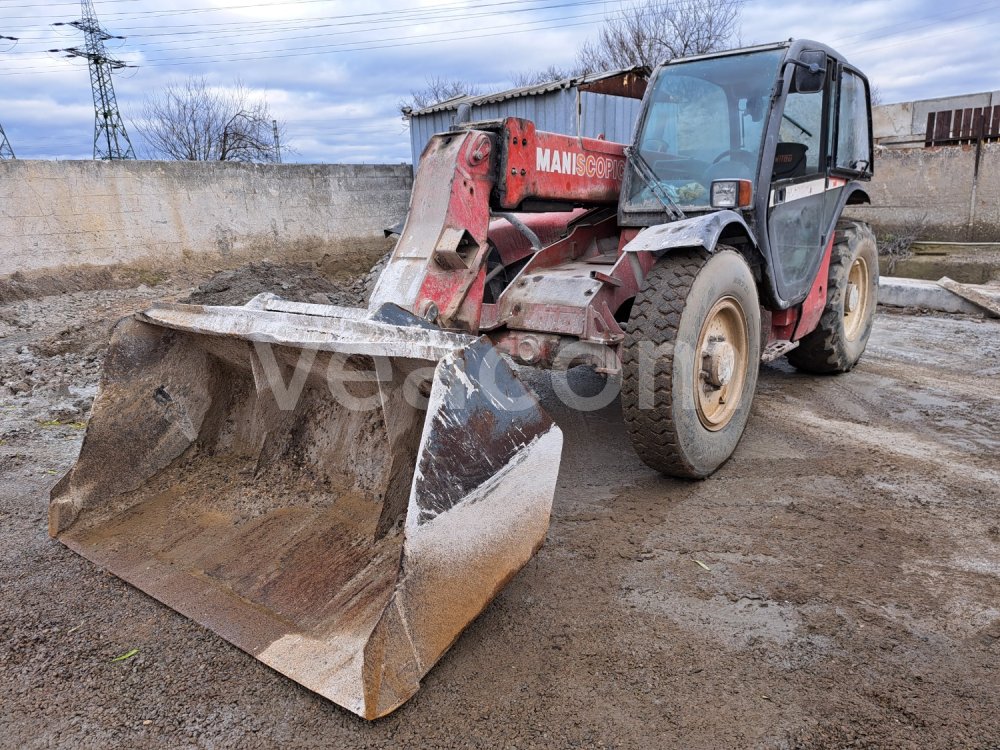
[622,246,760,479]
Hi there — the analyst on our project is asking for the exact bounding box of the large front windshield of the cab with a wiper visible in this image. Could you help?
[627,48,785,211]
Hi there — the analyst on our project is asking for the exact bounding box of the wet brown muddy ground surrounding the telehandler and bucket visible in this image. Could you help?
[0,269,1000,748]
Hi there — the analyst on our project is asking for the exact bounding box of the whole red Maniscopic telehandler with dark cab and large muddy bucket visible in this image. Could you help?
[50,40,878,719]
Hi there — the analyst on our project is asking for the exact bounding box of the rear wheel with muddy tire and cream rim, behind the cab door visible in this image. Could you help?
[788,221,878,374]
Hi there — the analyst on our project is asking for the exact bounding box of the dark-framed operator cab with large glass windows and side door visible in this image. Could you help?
[619,40,872,308]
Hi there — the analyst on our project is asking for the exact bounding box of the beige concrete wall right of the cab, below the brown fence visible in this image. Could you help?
[851,143,1000,242]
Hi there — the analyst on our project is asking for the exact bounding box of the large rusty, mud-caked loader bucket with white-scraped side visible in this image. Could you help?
[49,295,562,719]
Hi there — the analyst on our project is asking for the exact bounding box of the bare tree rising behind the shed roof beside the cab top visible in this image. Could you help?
[577,0,744,73]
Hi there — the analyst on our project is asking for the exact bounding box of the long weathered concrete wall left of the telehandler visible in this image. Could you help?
[0,160,413,277]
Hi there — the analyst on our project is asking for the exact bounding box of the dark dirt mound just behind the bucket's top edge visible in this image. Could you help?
[180,261,371,307]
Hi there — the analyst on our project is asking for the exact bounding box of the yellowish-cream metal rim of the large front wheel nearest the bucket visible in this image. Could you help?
[694,297,750,431]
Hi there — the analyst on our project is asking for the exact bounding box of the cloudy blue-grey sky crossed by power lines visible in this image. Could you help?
[0,0,1000,162]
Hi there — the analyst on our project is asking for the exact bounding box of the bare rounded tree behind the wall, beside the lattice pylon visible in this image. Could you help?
[135,77,284,162]
